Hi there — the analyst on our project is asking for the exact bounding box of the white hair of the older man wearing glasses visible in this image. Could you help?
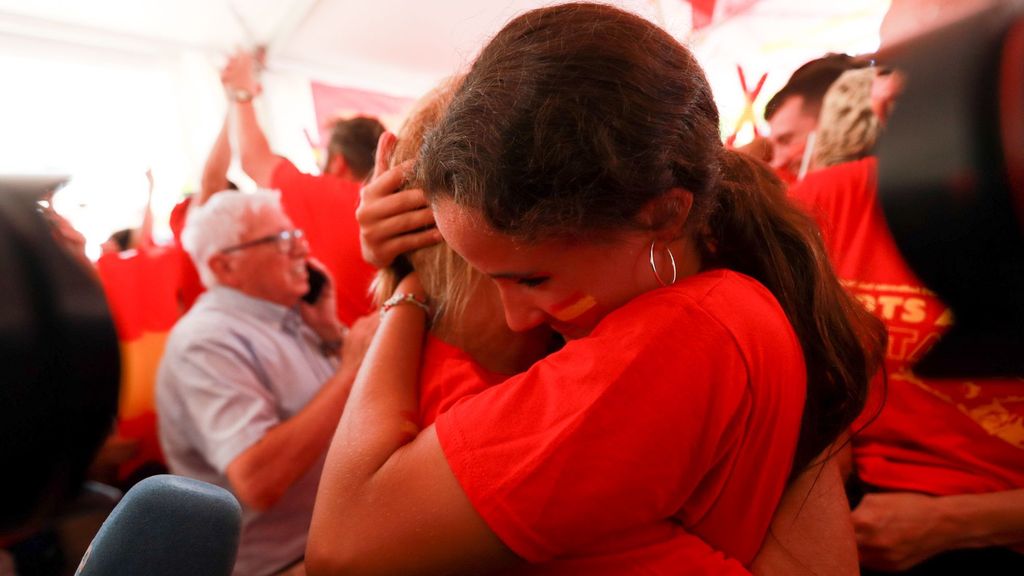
[181,190,282,288]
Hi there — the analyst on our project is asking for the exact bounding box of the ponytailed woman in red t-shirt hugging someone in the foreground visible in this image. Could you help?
[306,4,884,574]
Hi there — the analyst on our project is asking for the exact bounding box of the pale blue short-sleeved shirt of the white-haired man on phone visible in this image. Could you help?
[157,287,337,576]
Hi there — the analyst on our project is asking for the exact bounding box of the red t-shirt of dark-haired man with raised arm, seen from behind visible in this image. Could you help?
[270,159,377,326]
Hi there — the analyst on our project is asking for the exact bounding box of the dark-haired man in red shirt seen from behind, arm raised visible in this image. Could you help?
[221,52,384,325]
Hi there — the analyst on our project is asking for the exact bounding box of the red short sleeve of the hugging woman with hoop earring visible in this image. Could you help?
[436,290,750,562]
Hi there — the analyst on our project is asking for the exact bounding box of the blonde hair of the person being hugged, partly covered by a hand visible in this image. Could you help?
[374,77,484,332]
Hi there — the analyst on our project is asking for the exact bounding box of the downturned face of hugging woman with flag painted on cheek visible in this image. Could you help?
[434,200,657,339]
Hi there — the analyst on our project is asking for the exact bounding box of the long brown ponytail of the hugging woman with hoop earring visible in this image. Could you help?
[699,150,886,478]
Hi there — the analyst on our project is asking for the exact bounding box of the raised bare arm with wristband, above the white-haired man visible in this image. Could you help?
[220,51,283,188]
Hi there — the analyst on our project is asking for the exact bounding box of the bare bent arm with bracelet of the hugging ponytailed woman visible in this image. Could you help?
[306,275,516,575]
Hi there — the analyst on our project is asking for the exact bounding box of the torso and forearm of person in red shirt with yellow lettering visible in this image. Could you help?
[792,158,1024,574]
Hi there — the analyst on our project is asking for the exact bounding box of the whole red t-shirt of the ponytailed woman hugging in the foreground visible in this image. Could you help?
[435,271,806,574]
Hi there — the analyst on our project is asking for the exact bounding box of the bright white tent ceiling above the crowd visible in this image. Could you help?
[0,0,890,252]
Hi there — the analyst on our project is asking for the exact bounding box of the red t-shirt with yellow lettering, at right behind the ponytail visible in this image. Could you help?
[792,158,1024,495]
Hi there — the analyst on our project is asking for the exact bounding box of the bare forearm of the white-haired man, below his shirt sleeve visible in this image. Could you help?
[227,366,357,509]
